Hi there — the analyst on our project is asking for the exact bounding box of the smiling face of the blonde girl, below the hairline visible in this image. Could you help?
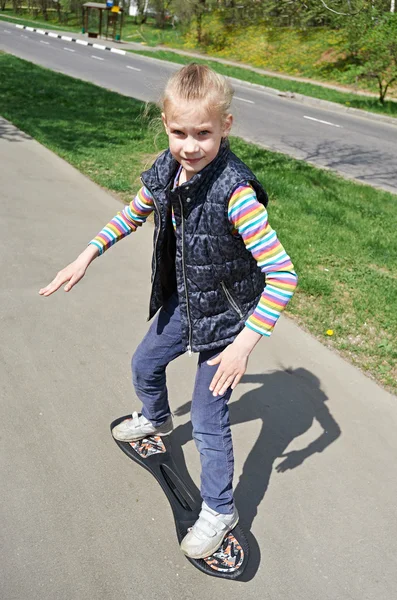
[162,101,233,181]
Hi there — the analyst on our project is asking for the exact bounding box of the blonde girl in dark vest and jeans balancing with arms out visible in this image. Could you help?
[39,64,297,558]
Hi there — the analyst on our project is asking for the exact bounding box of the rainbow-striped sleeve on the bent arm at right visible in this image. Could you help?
[228,185,298,336]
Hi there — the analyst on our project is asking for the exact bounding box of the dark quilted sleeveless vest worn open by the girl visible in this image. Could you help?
[142,140,267,352]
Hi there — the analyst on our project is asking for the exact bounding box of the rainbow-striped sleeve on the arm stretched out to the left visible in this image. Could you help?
[90,187,154,254]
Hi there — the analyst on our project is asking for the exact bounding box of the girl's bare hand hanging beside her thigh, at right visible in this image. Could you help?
[207,340,249,396]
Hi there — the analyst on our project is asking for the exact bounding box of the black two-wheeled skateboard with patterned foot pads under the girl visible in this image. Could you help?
[110,415,249,579]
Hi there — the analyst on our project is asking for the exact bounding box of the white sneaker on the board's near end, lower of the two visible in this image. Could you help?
[181,502,239,558]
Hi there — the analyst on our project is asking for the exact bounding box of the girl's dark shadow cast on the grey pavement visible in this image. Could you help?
[170,368,341,581]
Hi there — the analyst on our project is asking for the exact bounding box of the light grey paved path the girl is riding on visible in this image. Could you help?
[0,120,397,600]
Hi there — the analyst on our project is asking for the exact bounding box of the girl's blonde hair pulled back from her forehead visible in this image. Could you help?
[160,63,234,120]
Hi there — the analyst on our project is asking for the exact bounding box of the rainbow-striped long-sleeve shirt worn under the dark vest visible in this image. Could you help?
[90,185,297,336]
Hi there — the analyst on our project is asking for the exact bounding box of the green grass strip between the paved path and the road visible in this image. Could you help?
[0,54,397,392]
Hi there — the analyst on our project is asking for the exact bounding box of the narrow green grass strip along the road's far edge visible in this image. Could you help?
[131,50,397,117]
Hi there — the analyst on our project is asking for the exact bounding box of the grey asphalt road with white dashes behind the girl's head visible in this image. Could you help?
[0,22,397,193]
